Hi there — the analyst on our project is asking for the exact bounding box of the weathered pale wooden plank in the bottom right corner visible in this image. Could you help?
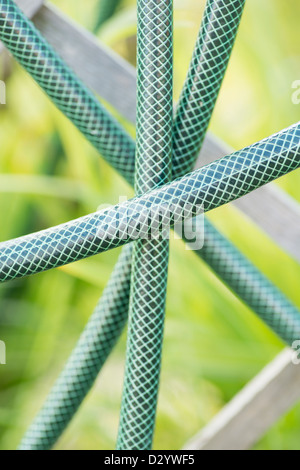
[185,349,300,450]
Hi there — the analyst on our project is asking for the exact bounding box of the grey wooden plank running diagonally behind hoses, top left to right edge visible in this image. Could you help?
[2,0,300,262]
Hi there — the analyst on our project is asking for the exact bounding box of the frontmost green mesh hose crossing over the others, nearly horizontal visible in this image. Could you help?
[0,123,300,282]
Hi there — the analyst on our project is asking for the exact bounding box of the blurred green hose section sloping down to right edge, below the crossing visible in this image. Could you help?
[184,219,300,346]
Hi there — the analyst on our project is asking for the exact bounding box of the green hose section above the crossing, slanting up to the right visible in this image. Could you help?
[173,0,246,178]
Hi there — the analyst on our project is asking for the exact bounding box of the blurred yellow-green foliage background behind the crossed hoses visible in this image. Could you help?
[0,0,300,449]
